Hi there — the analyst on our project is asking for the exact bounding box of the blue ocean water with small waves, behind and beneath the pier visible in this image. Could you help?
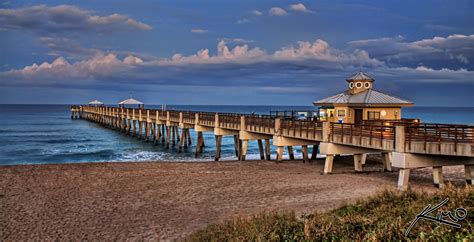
[0,105,474,165]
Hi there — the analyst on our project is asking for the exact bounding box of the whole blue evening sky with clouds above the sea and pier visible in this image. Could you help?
[0,0,474,107]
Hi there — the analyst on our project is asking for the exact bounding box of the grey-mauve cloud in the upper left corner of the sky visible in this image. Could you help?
[0,5,152,33]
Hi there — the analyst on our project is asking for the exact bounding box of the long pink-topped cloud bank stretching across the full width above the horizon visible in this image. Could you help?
[0,34,474,101]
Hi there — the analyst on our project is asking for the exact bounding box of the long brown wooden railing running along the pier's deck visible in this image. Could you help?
[76,106,474,156]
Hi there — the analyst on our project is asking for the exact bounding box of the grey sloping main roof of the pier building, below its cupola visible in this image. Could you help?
[313,89,413,105]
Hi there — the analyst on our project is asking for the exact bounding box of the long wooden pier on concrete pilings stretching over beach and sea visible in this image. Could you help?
[71,106,474,189]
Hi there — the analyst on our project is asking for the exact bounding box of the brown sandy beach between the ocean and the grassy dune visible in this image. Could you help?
[0,156,464,240]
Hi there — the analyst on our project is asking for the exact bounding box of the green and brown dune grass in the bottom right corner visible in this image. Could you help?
[189,185,474,241]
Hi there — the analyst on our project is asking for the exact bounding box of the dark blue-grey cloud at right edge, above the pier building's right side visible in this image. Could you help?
[349,35,474,70]
